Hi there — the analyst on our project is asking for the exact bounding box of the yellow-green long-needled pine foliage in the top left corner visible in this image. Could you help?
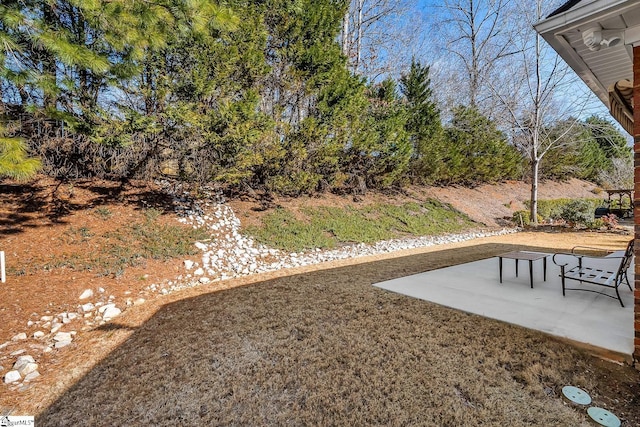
[0,0,234,134]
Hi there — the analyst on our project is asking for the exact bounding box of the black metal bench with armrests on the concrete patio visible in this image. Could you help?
[553,240,634,307]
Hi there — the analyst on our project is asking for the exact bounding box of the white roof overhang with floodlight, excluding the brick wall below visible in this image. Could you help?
[535,0,640,133]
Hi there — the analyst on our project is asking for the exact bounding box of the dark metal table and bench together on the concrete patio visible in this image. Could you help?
[498,240,634,307]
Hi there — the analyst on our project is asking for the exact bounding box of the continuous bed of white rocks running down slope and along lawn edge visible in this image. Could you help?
[158,181,517,295]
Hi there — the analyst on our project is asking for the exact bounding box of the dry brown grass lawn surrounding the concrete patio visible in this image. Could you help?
[36,233,640,426]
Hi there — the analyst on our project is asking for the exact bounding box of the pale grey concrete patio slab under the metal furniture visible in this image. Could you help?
[374,252,634,361]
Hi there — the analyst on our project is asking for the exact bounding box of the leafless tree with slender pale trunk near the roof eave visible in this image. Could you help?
[489,0,593,224]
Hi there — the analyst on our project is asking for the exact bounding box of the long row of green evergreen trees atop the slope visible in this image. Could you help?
[0,0,630,195]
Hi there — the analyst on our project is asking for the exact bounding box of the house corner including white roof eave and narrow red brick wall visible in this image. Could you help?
[535,0,640,366]
